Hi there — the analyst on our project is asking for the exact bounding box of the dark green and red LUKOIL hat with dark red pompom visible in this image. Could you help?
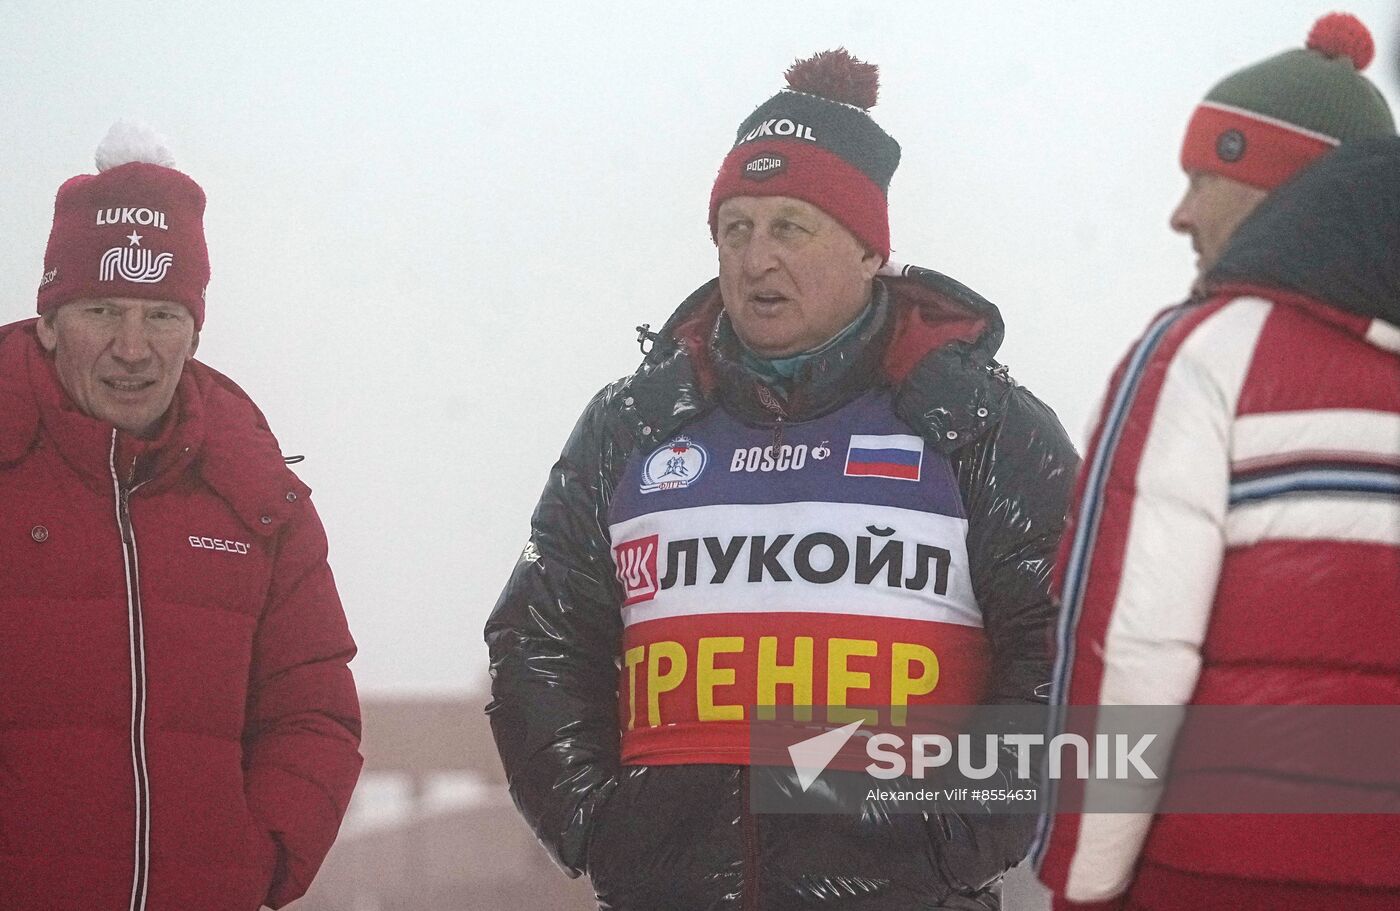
[710,48,899,260]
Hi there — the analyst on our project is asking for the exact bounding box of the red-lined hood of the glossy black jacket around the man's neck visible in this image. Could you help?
[616,263,1015,452]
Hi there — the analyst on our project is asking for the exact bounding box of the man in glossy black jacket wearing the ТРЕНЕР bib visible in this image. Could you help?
[486,50,1077,911]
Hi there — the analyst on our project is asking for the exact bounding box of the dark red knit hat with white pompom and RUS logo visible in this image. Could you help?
[38,122,209,330]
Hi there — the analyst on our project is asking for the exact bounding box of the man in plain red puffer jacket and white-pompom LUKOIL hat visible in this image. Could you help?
[0,123,360,911]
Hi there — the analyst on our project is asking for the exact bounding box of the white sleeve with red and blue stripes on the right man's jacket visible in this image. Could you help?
[1033,298,1271,907]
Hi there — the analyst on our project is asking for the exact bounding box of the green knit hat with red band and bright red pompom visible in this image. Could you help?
[1182,13,1396,190]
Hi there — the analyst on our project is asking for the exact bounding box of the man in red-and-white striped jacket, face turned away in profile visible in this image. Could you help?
[1033,14,1400,911]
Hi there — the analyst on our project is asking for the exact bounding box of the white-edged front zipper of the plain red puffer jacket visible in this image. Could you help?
[108,428,151,911]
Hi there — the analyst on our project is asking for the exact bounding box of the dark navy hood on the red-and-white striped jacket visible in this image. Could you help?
[1205,136,1400,326]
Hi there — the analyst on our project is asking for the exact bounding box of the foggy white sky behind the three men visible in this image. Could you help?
[0,0,1397,693]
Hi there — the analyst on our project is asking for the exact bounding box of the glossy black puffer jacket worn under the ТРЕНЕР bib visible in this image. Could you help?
[486,267,1078,911]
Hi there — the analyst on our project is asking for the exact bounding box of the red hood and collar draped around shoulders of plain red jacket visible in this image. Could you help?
[0,319,311,536]
